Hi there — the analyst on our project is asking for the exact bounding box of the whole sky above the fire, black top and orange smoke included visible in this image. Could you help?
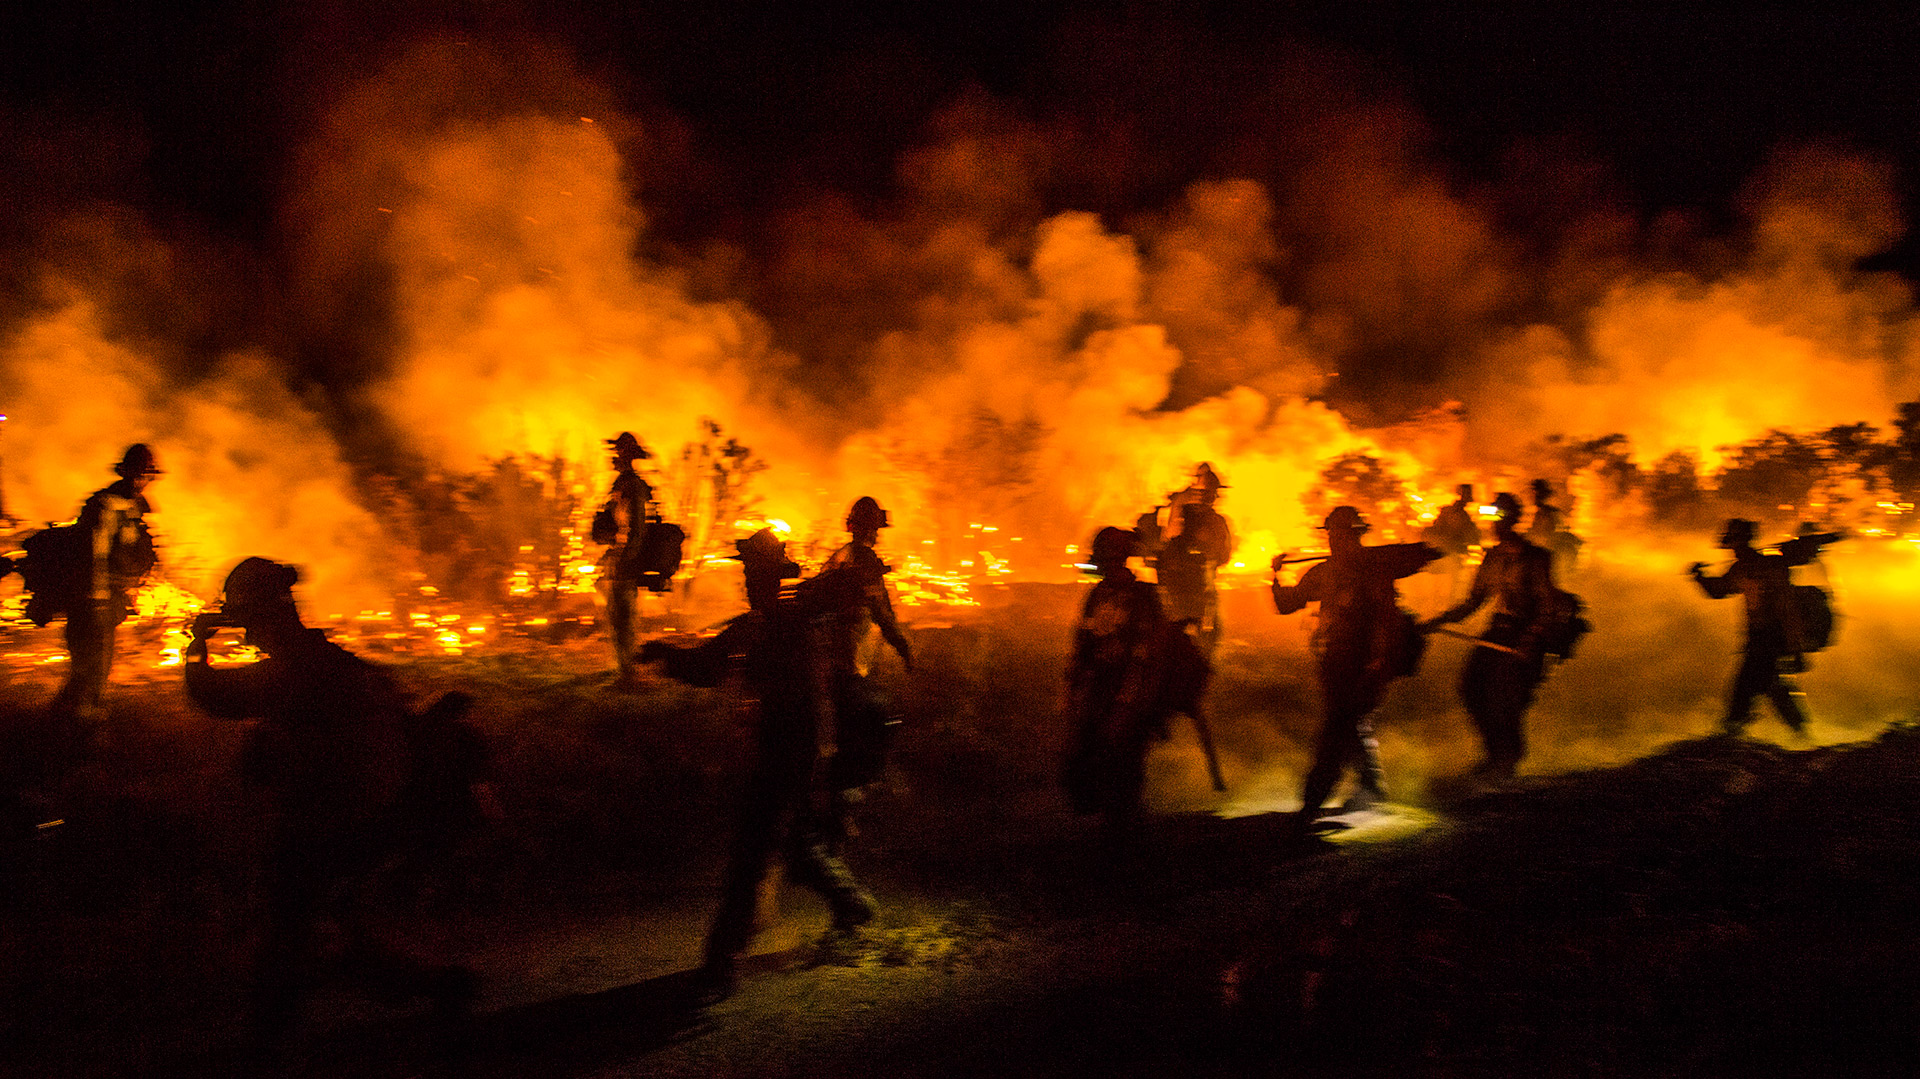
[0,2,1920,589]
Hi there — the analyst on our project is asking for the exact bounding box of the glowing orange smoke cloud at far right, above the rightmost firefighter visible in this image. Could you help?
[1459,150,1914,465]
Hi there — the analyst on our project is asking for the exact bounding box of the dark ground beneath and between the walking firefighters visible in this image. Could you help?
[0,574,1920,1077]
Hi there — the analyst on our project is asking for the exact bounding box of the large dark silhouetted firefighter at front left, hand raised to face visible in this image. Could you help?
[182,559,483,1048]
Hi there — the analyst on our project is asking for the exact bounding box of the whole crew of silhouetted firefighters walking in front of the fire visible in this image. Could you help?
[0,443,1839,1021]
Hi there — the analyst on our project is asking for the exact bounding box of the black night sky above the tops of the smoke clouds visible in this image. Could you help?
[0,2,1920,245]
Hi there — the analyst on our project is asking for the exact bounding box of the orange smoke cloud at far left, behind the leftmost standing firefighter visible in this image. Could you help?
[0,218,394,612]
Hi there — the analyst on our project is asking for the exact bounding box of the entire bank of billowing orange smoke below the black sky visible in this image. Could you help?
[0,23,1916,791]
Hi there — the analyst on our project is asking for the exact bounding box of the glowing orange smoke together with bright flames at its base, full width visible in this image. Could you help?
[0,42,1920,662]
